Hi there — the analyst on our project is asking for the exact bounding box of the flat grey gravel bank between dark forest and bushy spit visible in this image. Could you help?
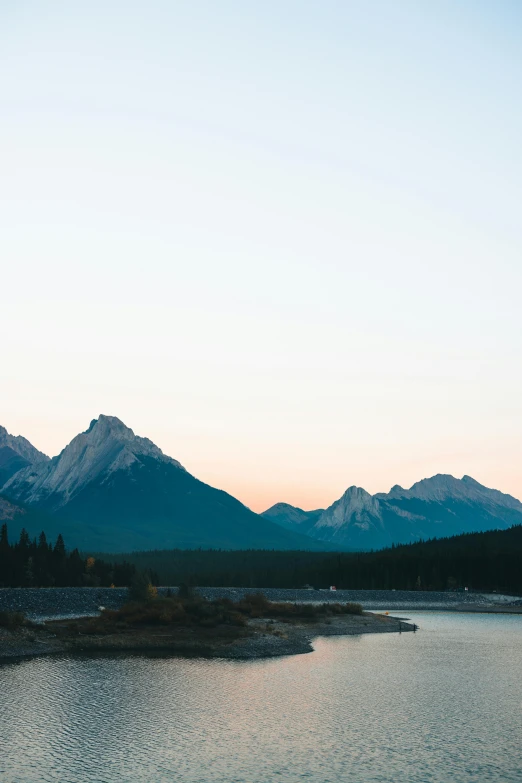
[0,587,522,620]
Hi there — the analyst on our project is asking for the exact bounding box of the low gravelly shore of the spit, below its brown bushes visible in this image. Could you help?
[0,612,416,663]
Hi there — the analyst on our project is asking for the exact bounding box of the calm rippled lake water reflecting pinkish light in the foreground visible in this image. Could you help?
[0,612,522,783]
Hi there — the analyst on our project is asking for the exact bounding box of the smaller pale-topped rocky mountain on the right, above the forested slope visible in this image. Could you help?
[264,474,522,550]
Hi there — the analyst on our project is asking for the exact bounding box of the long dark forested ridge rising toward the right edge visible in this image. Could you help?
[96,525,522,594]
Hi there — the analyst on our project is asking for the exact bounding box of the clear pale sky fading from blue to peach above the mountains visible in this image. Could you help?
[0,0,522,511]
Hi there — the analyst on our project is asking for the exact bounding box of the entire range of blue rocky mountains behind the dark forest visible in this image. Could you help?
[0,415,522,552]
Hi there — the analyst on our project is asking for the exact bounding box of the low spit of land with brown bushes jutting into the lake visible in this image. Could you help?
[0,585,416,659]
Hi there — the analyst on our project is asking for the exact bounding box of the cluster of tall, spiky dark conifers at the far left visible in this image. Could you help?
[0,524,136,587]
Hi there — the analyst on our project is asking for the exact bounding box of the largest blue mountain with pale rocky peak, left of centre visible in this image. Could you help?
[1,415,324,552]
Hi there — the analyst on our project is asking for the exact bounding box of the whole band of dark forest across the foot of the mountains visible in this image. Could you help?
[0,524,522,594]
